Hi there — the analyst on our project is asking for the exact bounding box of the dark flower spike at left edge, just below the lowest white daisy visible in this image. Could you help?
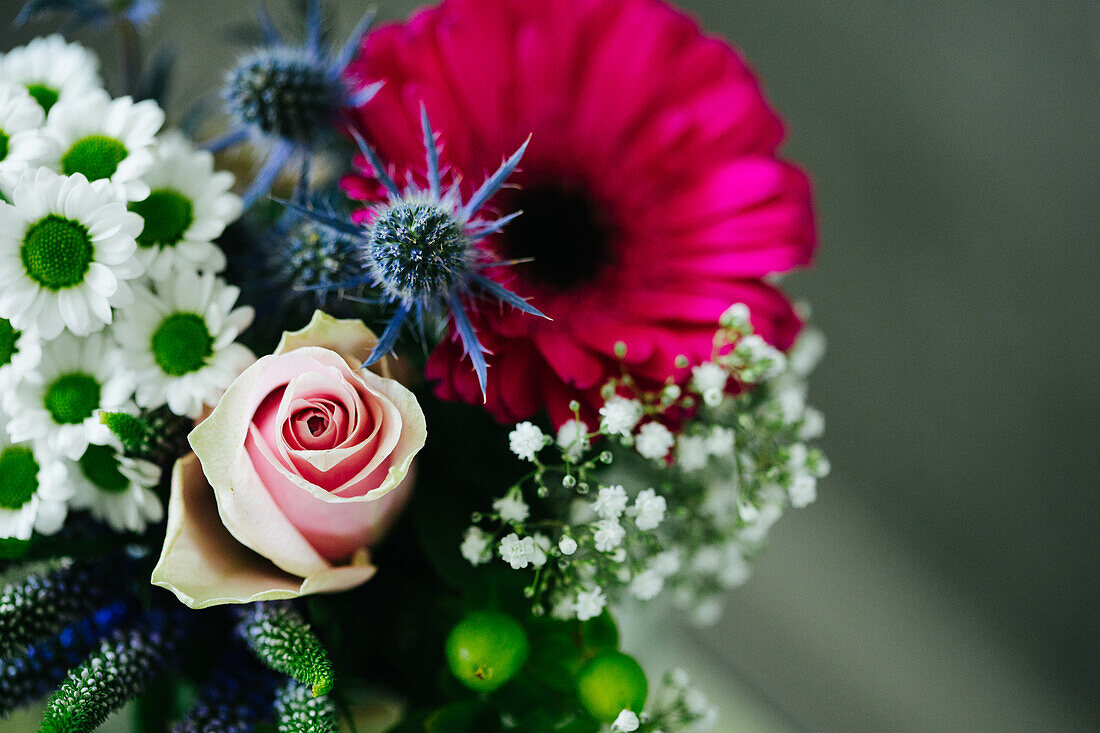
[0,561,118,658]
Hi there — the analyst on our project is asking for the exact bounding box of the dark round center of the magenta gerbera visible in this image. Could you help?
[504,184,615,291]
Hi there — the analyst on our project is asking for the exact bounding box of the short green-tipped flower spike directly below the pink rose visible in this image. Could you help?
[238,601,336,696]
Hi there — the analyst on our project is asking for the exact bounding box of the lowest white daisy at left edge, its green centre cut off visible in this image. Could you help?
[0,416,73,539]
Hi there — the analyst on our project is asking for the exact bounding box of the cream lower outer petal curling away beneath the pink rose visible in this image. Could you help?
[152,453,375,609]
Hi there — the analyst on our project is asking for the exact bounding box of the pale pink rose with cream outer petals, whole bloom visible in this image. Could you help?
[153,311,427,609]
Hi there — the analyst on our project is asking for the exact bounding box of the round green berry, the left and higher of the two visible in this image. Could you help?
[447,611,530,692]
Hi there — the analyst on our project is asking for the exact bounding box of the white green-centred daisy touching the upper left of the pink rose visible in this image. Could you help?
[114,271,254,418]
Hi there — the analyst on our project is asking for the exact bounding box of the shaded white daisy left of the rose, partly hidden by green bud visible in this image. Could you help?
[69,445,164,533]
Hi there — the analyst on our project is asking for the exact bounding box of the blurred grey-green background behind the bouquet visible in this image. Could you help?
[0,0,1100,732]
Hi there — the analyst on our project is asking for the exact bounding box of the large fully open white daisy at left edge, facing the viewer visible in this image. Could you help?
[0,168,142,339]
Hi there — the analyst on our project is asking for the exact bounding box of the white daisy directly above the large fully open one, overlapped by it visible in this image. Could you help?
[39,91,164,201]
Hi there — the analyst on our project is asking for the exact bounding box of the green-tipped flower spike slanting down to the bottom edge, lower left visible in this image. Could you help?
[39,613,179,733]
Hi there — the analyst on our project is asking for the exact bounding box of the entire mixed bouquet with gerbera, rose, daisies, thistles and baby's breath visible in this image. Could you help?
[0,0,828,733]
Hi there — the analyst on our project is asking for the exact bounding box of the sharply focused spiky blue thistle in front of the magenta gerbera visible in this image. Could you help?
[289,106,546,395]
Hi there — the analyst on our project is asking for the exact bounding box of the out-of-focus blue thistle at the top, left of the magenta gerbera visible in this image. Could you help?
[207,0,381,208]
